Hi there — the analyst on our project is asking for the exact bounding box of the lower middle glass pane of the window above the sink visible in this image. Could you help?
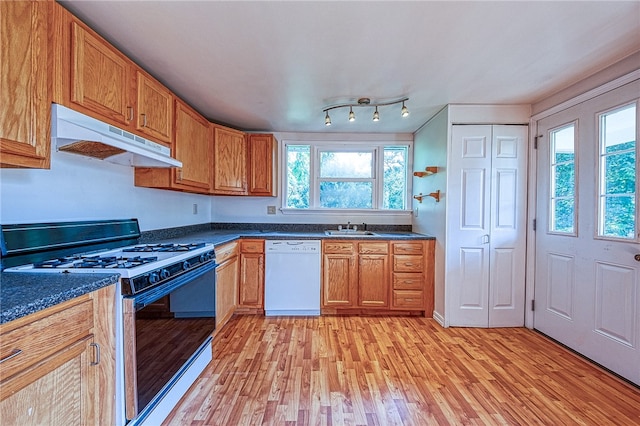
[320,181,373,209]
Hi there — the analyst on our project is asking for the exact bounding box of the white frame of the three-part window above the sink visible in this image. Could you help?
[280,140,413,216]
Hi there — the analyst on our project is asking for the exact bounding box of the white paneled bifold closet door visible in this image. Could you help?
[445,125,528,327]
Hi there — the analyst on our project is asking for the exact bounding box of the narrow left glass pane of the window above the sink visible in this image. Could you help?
[286,145,311,209]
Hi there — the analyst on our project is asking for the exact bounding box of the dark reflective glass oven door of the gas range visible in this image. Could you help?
[123,262,217,420]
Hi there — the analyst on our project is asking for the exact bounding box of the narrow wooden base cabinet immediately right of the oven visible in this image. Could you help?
[216,241,238,333]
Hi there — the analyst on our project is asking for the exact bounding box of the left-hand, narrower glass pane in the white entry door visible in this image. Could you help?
[549,123,576,234]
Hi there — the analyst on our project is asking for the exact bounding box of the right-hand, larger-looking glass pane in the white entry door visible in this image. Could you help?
[598,104,637,239]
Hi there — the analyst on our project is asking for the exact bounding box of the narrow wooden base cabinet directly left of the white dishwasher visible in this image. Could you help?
[236,239,264,314]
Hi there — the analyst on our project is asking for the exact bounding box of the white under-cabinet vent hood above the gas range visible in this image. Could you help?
[51,104,182,167]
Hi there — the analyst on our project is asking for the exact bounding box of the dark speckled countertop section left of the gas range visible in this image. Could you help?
[0,272,120,324]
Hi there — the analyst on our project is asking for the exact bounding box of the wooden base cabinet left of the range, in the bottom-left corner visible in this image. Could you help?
[0,286,115,425]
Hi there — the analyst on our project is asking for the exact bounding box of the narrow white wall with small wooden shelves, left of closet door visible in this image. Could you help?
[413,107,449,322]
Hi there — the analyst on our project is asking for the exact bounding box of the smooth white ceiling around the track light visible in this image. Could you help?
[61,0,640,133]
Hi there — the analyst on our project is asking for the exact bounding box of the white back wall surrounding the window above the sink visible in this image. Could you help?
[211,132,413,225]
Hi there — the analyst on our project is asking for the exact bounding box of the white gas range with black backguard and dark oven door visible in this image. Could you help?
[0,219,217,426]
